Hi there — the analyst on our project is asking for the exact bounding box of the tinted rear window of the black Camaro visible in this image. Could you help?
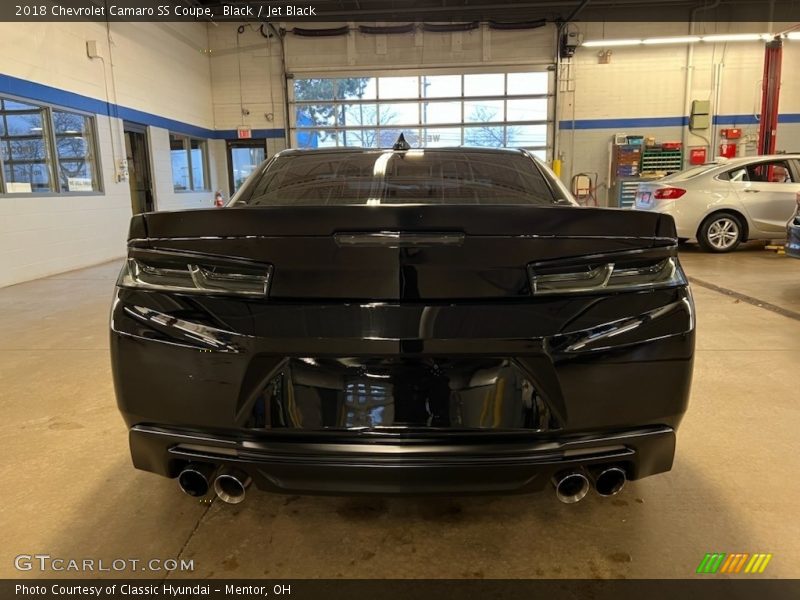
[234,150,556,206]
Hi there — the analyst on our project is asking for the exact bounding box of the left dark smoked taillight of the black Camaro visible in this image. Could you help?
[117,251,272,298]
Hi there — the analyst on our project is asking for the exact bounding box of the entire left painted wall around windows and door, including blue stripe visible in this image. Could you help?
[0,22,222,286]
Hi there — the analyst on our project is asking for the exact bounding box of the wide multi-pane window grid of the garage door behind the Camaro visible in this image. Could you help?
[292,71,552,159]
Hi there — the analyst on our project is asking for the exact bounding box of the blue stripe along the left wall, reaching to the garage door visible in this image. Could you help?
[0,74,285,140]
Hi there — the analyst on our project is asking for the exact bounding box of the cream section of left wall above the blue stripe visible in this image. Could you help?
[0,22,213,128]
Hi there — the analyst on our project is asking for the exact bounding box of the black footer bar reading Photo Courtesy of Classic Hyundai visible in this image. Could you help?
[0,576,800,600]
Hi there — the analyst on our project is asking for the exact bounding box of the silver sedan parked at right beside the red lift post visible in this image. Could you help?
[635,154,800,252]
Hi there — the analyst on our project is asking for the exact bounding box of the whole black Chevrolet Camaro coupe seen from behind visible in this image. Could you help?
[111,144,694,502]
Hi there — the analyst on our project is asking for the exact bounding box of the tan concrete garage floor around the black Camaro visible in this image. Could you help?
[0,247,800,578]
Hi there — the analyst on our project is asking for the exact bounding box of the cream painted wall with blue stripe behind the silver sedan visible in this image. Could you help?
[559,23,800,204]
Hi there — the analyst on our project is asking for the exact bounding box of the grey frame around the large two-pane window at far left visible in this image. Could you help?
[0,93,106,198]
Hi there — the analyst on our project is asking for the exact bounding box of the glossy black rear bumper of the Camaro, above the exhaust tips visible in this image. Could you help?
[111,287,694,494]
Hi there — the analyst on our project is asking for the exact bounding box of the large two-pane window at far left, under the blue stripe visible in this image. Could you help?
[0,98,101,194]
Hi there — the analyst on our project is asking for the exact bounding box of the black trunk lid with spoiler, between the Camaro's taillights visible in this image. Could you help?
[130,205,675,301]
